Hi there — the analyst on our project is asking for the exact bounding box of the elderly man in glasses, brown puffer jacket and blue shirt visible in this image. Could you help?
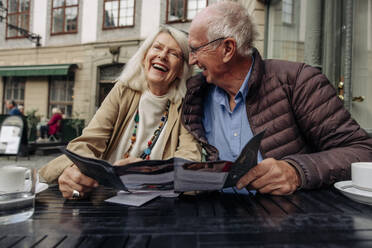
[182,2,372,195]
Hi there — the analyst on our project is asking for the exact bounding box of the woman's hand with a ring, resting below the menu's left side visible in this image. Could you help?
[58,165,98,199]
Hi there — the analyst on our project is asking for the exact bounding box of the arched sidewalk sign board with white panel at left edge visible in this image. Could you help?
[0,115,30,160]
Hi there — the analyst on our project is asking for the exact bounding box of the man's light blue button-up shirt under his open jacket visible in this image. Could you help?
[203,57,262,193]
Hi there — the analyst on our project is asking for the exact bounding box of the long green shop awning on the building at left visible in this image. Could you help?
[0,64,77,76]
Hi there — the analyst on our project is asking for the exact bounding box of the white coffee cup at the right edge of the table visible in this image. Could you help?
[351,162,372,191]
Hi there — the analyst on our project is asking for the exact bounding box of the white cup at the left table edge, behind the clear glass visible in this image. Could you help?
[0,166,30,192]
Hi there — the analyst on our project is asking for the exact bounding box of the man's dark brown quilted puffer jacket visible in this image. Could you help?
[182,48,372,189]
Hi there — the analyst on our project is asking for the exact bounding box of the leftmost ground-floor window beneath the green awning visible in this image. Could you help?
[3,77,26,113]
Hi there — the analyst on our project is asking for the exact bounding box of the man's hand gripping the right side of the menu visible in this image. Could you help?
[236,158,301,195]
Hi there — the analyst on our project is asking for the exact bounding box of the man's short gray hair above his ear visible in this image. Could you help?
[207,1,258,57]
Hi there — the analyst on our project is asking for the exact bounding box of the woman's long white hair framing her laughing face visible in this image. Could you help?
[117,26,192,102]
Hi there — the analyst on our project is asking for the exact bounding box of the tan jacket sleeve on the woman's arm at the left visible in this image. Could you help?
[39,84,122,183]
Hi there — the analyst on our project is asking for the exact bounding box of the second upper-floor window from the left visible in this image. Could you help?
[51,0,79,34]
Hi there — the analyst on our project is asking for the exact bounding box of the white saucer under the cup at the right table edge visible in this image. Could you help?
[334,181,372,205]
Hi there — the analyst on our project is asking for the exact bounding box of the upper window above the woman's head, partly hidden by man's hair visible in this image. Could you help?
[167,0,208,23]
